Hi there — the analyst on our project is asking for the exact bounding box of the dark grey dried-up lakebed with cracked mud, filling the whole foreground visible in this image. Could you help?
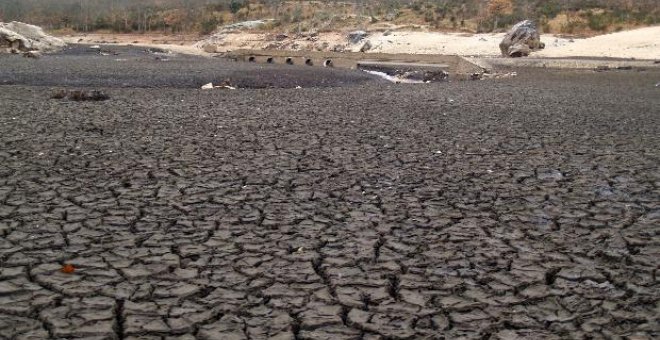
[0,45,660,340]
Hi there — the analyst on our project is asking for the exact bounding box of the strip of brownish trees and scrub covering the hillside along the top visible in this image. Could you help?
[0,0,660,34]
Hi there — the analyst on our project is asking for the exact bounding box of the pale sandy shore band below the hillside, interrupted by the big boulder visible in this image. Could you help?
[62,26,660,60]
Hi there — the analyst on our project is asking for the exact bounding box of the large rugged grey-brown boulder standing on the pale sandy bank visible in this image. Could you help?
[500,20,545,58]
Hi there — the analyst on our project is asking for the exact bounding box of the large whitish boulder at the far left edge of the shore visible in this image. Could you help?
[0,21,66,53]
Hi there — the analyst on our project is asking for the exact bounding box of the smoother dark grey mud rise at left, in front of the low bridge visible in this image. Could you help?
[0,45,378,89]
